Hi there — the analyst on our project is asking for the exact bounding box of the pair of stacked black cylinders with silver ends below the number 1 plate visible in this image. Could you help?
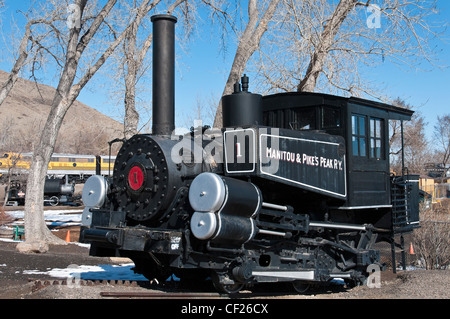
[189,172,262,244]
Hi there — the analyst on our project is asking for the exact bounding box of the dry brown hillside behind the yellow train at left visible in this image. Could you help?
[0,70,123,154]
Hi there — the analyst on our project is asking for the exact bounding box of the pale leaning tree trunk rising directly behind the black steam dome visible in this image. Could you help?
[214,0,280,127]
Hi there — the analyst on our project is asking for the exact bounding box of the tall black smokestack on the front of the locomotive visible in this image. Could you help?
[151,14,177,135]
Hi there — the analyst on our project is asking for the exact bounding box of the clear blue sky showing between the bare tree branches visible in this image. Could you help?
[0,0,450,139]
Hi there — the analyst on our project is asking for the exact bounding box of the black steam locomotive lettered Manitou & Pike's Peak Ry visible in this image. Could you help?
[81,15,419,293]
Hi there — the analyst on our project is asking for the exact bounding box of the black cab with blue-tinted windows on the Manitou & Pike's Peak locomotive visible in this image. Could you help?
[263,93,413,210]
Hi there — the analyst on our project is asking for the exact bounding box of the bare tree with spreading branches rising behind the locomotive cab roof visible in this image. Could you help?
[255,0,444,100]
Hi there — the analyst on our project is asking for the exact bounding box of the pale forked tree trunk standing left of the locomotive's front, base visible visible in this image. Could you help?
[17,0,160,252]
